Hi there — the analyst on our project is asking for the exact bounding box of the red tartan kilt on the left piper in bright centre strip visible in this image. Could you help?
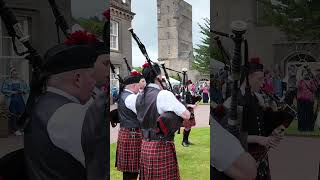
[116,128,142,172]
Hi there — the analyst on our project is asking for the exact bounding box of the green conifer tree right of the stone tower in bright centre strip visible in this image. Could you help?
[192,18,222,75]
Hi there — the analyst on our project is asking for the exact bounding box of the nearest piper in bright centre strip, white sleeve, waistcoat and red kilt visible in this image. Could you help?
[127,64,192,180]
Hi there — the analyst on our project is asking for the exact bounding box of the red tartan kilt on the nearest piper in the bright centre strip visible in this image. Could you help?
[140,140,180,180]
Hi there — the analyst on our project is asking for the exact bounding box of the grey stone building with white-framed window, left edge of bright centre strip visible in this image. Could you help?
[110,0,135,88]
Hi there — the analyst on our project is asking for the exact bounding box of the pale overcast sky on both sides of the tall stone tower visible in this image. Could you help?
[131,0,210,66]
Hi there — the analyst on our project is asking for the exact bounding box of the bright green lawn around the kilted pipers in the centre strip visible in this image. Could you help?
[110,128,210,180]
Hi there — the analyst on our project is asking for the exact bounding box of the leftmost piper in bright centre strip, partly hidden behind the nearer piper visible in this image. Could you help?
[116,71,143,180]
